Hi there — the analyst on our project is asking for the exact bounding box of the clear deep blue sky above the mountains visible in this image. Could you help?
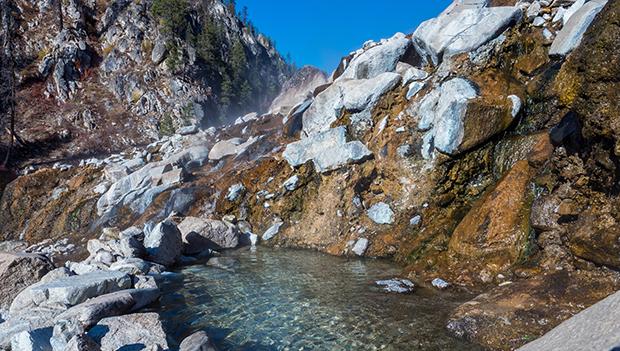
[237,0,451,73]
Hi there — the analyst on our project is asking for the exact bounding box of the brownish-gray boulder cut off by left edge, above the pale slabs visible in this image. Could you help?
[0,252,54,309]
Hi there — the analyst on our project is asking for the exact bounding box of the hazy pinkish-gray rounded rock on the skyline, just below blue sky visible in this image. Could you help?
[269,66,327,115]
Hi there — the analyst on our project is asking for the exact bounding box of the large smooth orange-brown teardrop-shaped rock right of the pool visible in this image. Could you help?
[449,160,533,274]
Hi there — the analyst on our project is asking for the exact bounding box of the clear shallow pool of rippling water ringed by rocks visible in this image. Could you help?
[159,247,478,350]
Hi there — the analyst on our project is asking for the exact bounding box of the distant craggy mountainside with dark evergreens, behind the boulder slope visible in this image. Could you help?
[3,0,292,168]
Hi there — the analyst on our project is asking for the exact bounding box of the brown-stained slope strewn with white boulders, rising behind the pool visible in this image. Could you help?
[0,0,620,350]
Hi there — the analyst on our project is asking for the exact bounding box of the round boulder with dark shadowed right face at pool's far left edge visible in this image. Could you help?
[144,220,183,266]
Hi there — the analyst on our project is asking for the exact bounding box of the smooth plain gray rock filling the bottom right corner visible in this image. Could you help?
[518,292,620,351]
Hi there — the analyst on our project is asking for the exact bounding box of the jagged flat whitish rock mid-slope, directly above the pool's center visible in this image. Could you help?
[282,126,372,173]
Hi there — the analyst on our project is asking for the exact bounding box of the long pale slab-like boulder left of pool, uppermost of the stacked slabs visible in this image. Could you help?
[9,271,131,316]
